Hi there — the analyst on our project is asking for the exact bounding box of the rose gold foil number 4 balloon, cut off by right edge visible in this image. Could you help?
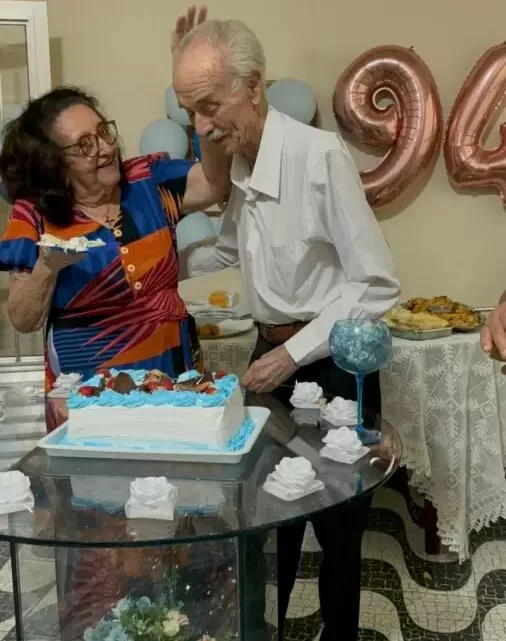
[444,43,506,204]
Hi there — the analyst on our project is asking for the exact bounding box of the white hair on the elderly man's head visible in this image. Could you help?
[176,20,265,91]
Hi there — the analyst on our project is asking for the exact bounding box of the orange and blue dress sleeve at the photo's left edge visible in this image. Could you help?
[0,200,41,272]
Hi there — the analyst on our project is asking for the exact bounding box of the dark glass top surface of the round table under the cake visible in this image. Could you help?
[0,394,401,547]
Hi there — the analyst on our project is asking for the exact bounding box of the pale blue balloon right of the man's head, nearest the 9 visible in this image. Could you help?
[267,78,317,125]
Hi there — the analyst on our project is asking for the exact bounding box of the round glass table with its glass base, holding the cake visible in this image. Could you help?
[0,395,401,641]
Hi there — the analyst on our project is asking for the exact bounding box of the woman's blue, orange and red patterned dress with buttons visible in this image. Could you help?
[0,154,200,429]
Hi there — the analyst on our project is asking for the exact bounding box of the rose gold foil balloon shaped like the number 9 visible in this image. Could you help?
[333,45,443,208]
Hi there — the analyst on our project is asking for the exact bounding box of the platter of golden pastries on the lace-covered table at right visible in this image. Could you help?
[383,296,483,340]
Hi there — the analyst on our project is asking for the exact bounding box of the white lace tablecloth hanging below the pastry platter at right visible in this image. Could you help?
[381,333,506,559]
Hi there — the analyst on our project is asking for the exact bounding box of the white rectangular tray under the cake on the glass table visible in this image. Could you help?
[37,407,271,463]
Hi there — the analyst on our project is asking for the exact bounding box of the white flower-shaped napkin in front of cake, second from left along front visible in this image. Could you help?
[125,476,178,521]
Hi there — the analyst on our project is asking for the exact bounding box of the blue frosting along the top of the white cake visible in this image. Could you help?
[67,369,239,409]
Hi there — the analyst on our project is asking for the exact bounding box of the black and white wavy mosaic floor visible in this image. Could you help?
[0,480,506,641]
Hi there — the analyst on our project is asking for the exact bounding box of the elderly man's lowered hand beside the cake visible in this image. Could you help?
[241,345,298,394]
